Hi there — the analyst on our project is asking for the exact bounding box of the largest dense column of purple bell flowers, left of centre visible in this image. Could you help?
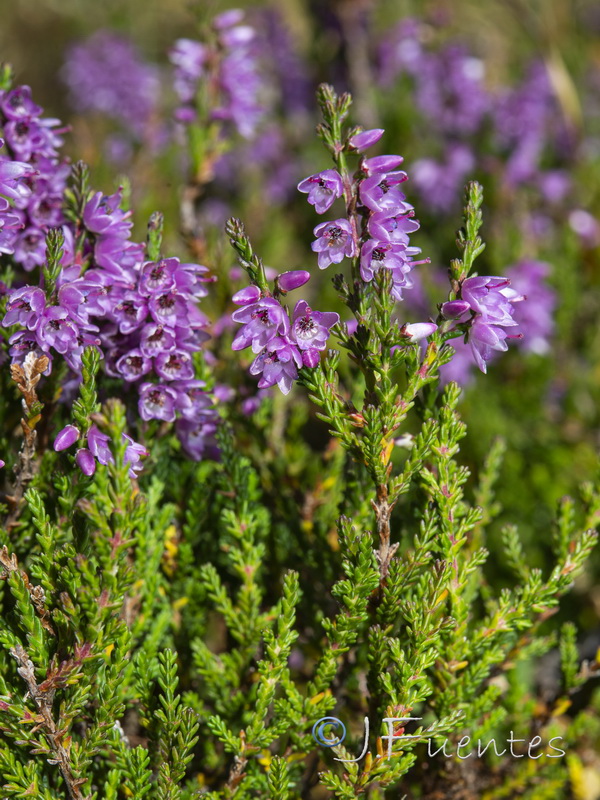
[83,193,216,457]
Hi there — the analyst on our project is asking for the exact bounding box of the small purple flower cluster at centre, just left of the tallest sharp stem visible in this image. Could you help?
[232,270,340,394]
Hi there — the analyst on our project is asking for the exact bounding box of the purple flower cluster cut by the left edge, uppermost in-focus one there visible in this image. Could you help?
[0,86,69,272]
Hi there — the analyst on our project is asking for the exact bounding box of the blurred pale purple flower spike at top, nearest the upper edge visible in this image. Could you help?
[170,9,263,138]
